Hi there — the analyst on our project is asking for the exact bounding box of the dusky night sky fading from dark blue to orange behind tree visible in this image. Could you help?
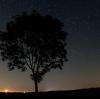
[0,0,100,91]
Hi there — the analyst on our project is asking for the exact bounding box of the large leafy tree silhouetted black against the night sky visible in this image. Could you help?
[0,10,67,92]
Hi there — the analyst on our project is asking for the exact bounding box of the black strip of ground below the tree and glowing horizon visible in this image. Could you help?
[0,88,100,99]
